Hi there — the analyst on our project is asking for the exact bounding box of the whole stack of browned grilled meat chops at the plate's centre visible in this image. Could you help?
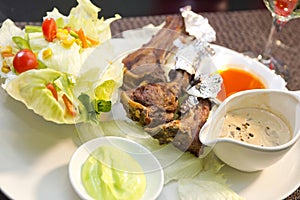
[121,16,211,156]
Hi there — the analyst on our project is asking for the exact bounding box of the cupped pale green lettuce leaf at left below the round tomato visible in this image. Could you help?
[3,69,79,124]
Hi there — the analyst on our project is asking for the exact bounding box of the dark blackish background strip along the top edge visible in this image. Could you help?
[0,0,265,22]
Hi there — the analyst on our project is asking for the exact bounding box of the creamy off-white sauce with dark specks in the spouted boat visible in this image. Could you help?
[220,108,291,147]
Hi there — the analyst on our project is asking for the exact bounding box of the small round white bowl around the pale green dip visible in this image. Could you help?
[69,136,164,200]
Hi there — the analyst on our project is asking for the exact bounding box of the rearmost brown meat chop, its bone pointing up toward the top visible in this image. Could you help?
[122,16,184,90]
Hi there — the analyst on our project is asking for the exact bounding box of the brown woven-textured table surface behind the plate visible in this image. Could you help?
[0,10,300,200]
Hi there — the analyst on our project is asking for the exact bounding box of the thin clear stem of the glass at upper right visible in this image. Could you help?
[260,16,286,65]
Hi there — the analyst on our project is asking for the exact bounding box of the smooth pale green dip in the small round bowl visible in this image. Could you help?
[81,146,146,200]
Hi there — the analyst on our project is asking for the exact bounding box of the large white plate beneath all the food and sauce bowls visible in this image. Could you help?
[0,45,300,200]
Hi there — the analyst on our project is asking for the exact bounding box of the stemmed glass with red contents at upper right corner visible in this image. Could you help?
[258,0,300,81]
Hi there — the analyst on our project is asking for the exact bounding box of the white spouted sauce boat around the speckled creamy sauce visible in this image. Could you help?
[199,89,300,172]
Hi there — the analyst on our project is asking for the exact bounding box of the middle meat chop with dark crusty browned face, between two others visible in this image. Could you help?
[121,70,190,127]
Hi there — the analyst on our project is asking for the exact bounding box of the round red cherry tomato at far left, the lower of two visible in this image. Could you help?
[13,49,39,73]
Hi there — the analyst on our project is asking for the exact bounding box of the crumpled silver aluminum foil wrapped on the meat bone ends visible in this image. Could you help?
[174,6,223,103]
